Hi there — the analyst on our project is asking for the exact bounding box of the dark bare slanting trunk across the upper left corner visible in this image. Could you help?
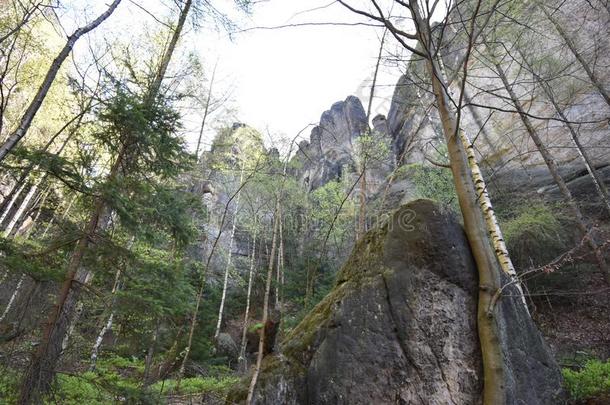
[0,0,121,162]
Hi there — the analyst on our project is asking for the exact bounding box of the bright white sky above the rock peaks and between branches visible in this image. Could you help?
[63,0,401,152]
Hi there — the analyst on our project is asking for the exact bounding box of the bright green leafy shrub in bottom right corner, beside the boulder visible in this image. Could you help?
[562,360,610,400]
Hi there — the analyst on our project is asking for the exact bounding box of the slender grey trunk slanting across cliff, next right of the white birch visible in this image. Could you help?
[495,63,610,284]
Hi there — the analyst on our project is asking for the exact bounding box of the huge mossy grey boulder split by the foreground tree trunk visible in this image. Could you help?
[228,200,560,404]
